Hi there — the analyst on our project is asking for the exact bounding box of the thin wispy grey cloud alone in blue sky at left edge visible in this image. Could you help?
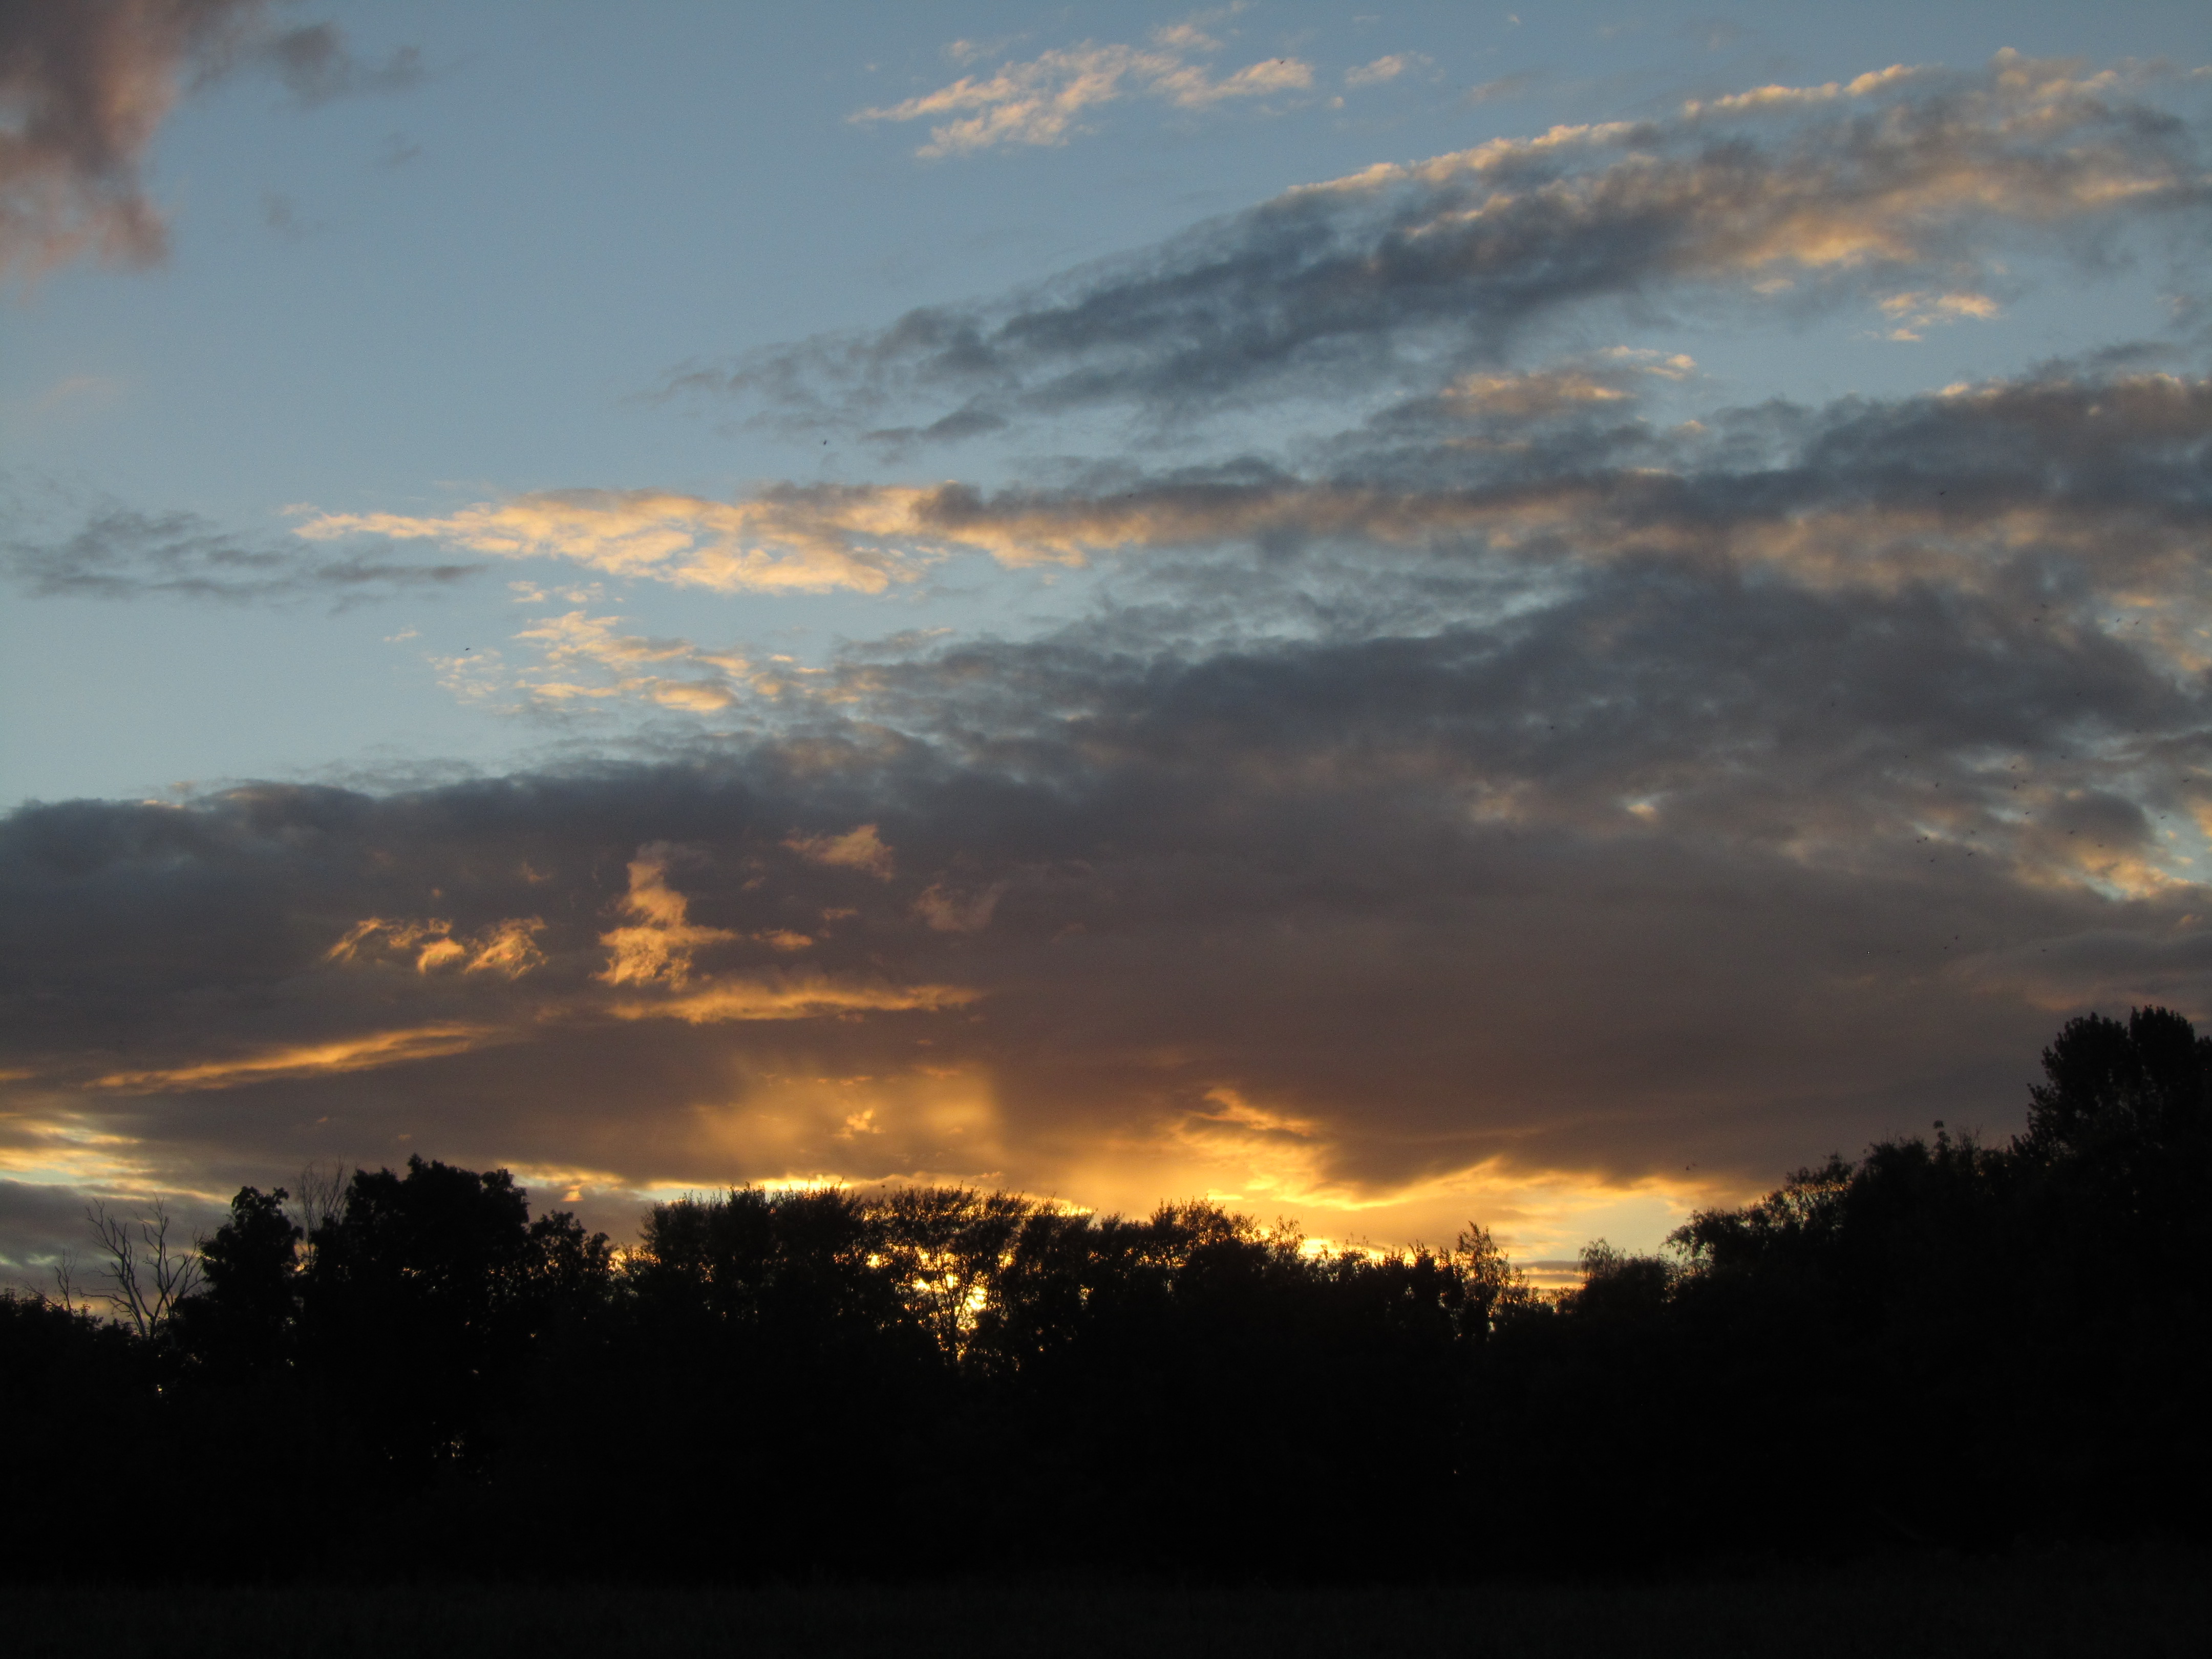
[0,506,482,606]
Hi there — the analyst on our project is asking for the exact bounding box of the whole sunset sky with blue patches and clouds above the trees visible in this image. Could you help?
[0,0,2212,1283]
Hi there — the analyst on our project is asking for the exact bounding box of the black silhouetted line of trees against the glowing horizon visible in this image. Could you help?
[0,1009,2212,1579]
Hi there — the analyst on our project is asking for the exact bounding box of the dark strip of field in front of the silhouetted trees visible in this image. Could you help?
[0,1553,2212,1659]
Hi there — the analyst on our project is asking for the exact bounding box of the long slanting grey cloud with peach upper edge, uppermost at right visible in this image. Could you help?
[694,53,2212,440]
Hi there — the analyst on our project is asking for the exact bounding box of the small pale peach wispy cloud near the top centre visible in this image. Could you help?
[849,25,1314,159]
